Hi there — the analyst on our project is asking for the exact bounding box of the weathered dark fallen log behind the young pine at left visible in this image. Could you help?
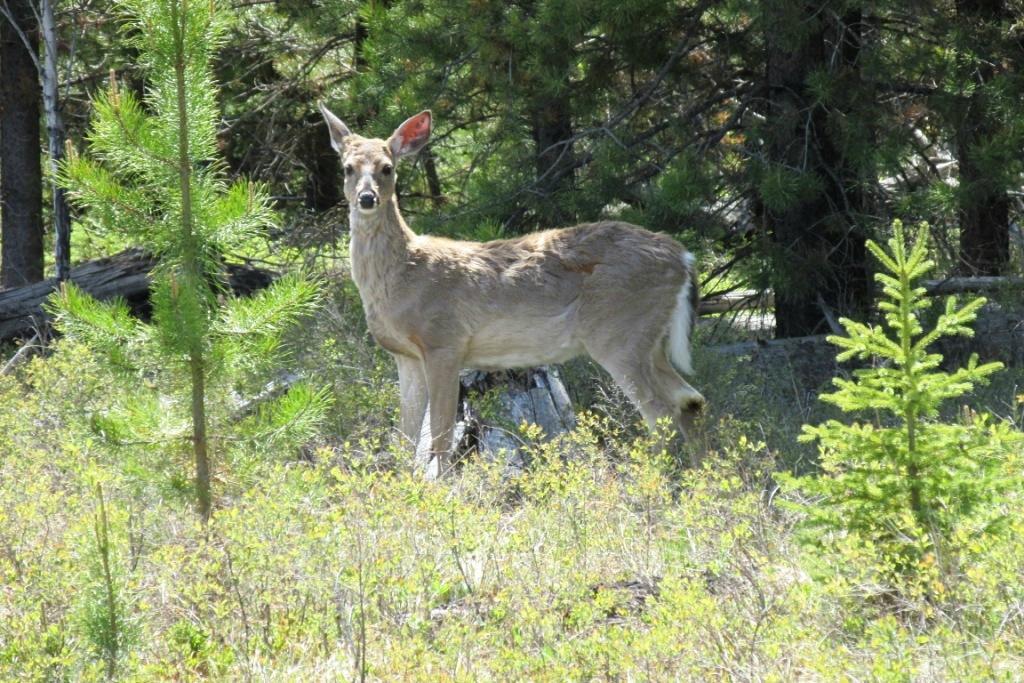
[0,249,276,341]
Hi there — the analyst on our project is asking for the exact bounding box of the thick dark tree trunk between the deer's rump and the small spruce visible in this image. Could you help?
[764,2,870,337]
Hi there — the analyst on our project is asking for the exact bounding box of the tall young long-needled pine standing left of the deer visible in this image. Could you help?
[54,0,326,519]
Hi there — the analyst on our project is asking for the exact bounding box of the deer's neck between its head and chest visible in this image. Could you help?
[348,198,416,301]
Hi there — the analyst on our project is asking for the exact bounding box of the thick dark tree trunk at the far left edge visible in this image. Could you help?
[0,0,43,287]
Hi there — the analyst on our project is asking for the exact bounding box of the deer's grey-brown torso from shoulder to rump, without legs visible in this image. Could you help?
[396,221,686,369]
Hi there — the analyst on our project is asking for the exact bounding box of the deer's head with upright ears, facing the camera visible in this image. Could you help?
[319,103,431,215]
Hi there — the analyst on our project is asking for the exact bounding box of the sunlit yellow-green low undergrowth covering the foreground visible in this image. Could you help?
[0,331,1024,681]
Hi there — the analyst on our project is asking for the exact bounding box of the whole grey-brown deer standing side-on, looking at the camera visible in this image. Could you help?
[318,102,705,473]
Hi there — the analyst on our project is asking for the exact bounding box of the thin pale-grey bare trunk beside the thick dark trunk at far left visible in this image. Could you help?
[40,0,71,282]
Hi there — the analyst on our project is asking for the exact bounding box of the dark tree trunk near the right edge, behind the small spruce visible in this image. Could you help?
[954,0,1010,275]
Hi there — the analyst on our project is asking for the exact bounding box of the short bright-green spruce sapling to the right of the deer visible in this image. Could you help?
[778,221,1021,578]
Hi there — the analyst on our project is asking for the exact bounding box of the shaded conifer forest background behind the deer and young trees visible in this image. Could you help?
[0,0,1024,336]
